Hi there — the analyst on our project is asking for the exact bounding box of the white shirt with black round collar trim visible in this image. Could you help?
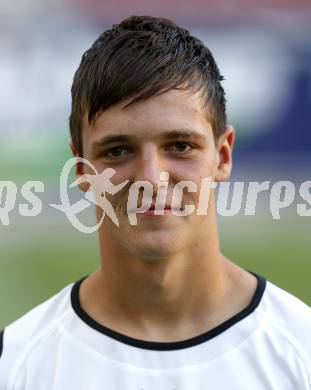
[0,275,311,390]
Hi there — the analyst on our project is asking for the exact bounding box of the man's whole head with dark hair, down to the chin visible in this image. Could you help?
[70,17,234,259]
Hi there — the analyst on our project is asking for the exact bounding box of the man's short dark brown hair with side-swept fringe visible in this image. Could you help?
[69,16,226,156]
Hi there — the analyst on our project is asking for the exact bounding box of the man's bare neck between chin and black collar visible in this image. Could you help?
[80,204,256,341]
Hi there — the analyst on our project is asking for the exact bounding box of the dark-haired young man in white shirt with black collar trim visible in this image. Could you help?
[0,13,311,390]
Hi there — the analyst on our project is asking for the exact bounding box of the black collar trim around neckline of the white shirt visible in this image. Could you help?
[71,272,266,351]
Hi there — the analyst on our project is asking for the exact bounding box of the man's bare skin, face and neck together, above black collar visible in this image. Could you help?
[70,90,257,342]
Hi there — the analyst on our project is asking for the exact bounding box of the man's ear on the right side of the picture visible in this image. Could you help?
[215,125,235,182]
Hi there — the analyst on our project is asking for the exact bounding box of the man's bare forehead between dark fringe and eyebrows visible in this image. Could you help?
[82,90,211,145]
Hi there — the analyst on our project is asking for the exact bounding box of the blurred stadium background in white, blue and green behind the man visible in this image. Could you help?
[0,0,311,329]
